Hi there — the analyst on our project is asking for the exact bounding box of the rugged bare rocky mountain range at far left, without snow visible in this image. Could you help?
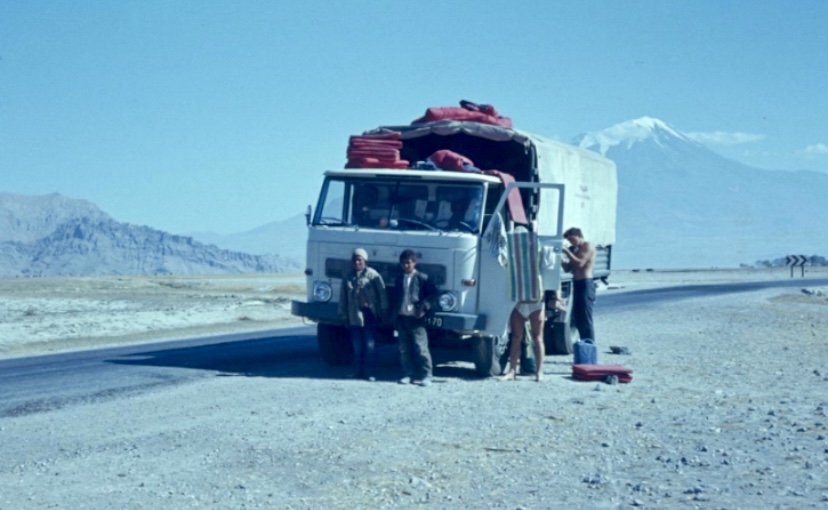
[0,193,300,277]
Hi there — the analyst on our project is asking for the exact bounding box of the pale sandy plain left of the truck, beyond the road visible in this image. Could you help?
[0,273,305,358]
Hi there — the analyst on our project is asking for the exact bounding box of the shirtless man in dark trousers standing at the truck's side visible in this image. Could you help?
[563,227,595,342]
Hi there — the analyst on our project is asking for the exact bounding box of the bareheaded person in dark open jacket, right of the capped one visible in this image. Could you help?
[392,250,437,386]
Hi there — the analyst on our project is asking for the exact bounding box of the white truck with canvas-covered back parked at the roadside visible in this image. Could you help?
[291,120,618,376]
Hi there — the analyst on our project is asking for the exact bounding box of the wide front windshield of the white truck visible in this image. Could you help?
[313,177,485,233]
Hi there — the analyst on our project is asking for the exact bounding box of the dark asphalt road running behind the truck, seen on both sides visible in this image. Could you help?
[0,279,828,418]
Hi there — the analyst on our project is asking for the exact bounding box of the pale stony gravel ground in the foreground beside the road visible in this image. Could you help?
[0,273,828,510]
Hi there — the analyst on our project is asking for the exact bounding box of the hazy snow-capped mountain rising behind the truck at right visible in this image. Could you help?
[573,117,828,268]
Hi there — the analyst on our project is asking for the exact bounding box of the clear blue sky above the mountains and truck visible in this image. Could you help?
[0,0,828,233]
